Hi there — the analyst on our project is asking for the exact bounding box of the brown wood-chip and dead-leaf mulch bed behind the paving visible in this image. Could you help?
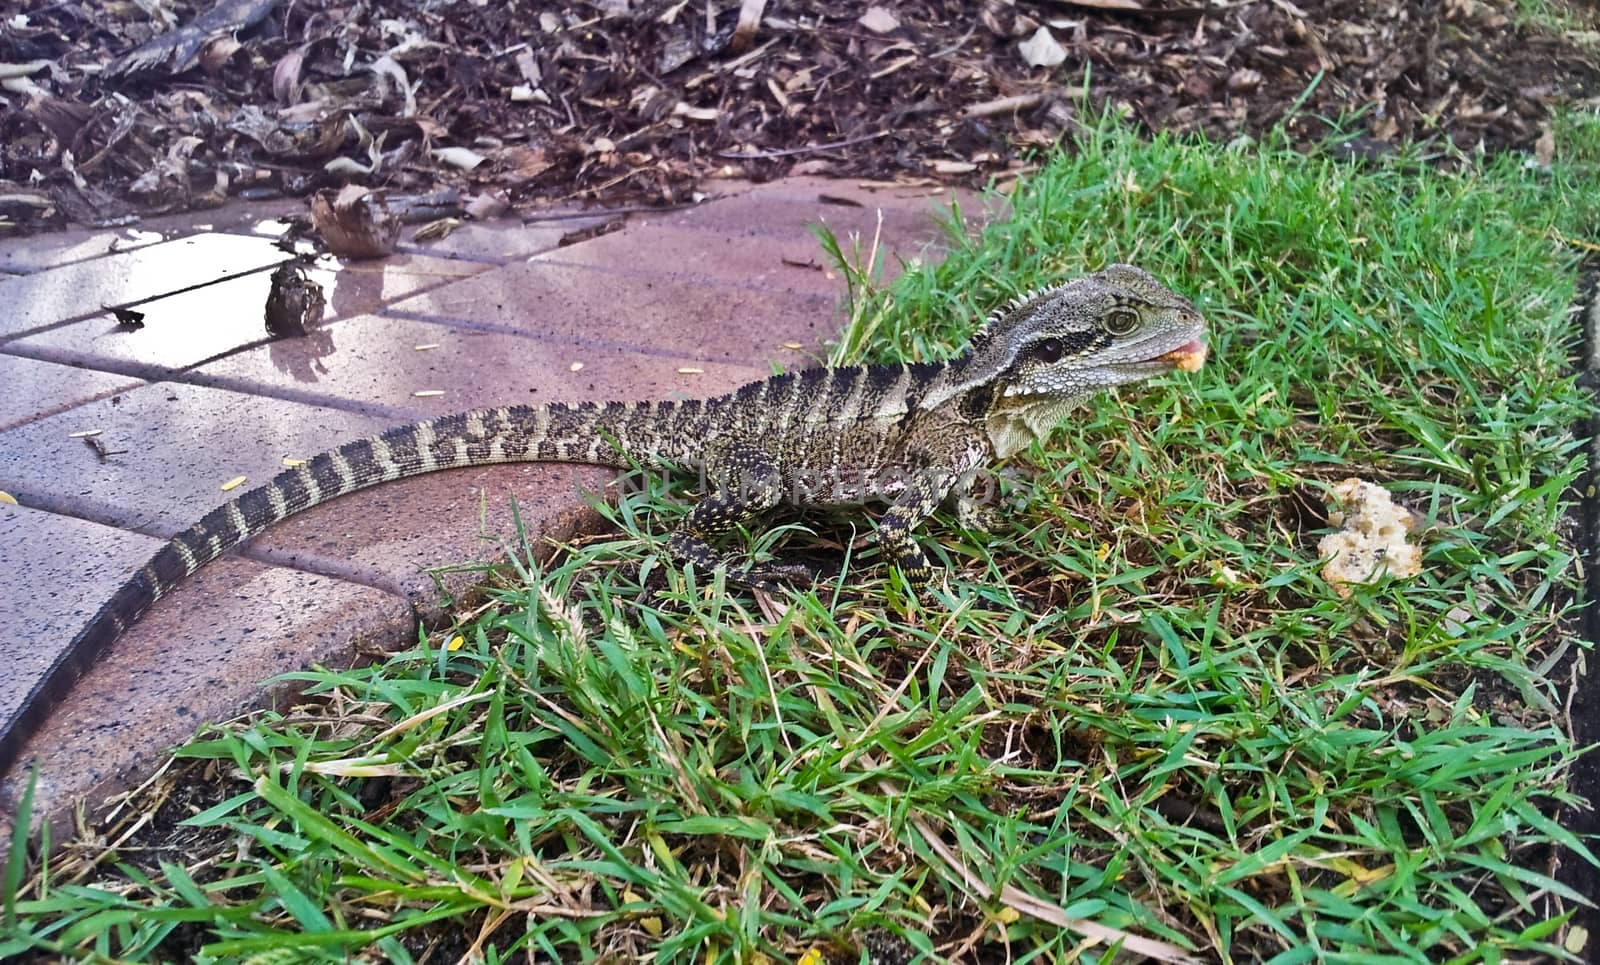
[0,0,1600,234]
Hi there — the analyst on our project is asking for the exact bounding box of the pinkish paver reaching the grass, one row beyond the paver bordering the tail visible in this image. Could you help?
[387,259,840,368]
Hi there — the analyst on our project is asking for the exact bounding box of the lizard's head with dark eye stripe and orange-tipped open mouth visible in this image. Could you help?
[960,264,1206,456]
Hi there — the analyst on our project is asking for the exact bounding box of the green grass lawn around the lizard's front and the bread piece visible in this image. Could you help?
[9,122,1600,962]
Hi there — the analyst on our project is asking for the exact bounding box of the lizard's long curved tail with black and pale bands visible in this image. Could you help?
[0,400,700,773]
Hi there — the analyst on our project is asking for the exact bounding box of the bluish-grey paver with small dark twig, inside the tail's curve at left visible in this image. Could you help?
[0,382,392,536]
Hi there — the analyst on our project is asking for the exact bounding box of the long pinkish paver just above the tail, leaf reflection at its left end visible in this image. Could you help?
[189,315,766,421]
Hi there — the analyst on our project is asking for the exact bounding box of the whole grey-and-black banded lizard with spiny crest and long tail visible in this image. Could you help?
[0,264,1206,773]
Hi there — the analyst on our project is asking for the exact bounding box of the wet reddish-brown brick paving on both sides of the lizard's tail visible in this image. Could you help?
[0,179,978,819]
